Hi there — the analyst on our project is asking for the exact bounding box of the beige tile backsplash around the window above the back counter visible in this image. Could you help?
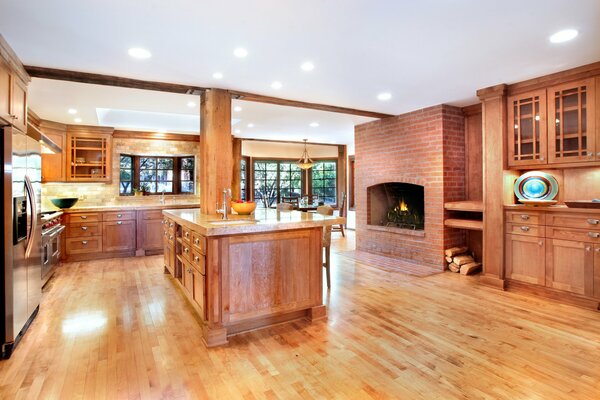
[42,138,200,210]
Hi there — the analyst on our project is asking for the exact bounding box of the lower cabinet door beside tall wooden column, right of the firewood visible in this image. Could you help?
[505,235,546,285]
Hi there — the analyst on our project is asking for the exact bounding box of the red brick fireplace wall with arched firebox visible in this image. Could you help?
[355,105,465,269]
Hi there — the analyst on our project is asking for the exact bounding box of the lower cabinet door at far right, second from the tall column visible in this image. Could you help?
[546,239,594,296]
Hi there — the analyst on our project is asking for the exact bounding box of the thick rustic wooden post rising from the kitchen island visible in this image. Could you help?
[200,89,233,214]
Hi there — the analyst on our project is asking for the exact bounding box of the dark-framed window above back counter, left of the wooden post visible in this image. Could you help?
[119,154,195,196]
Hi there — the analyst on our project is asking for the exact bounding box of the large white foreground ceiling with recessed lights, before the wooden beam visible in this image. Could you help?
[0,0,600,119]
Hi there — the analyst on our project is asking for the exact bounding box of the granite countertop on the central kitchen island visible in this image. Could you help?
[163,209,346,236]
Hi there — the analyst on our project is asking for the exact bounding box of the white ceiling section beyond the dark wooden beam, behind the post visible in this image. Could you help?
[29,78,373,144]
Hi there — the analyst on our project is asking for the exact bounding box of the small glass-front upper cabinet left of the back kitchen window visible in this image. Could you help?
[66,126,112,182]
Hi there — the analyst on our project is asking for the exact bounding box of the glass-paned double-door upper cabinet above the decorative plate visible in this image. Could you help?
[507,78,600,168]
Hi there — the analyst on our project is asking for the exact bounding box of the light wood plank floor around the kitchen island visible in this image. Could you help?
[0,234,600,400]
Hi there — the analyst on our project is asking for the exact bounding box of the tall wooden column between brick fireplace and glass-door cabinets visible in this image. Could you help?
[477,84,506,289]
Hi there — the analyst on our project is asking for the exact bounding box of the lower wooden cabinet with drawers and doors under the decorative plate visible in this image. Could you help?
[505,209,600,299]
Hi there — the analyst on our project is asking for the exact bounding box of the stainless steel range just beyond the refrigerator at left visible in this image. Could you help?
[42,211,65,286]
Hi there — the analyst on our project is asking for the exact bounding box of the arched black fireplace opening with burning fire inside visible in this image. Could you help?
[367,182,425,231]
